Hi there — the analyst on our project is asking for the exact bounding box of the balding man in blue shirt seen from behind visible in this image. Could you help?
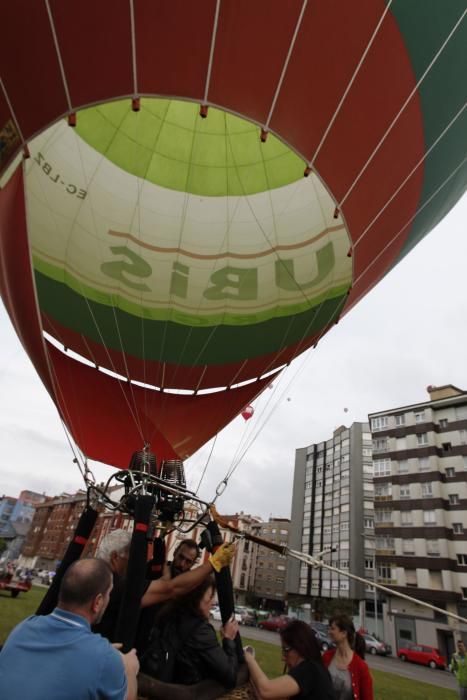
[0,559,139,700]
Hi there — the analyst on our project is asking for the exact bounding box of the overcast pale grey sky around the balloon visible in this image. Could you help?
[0,191,467,518]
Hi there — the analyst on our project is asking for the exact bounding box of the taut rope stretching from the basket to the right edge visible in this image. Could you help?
[211,506,467,624]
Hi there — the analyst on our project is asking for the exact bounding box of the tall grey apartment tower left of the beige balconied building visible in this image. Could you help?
[287,423,374,629]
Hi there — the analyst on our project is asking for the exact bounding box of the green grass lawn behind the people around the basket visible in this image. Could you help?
[0,586,457,700]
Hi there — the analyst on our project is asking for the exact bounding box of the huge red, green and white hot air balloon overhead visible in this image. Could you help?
[0,0,467,467]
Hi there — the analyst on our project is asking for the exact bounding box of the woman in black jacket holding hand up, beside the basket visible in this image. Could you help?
[141,578,238,688]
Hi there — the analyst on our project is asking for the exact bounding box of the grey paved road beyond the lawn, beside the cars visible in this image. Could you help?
[230,626,457,690]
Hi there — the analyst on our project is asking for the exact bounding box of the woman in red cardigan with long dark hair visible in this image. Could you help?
[323,615,373,700]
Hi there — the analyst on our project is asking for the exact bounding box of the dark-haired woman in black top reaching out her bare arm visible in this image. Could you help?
[245,620,336,700]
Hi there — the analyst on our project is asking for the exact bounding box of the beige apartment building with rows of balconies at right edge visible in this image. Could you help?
[369,385,467,655]
